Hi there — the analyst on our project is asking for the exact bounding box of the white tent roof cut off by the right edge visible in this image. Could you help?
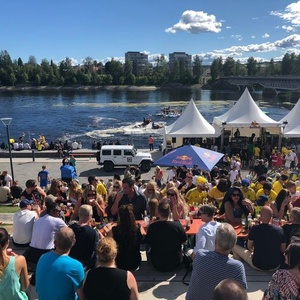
[278,99,300,137]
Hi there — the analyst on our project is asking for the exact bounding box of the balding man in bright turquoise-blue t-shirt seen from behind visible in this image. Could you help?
[36,227,85,300]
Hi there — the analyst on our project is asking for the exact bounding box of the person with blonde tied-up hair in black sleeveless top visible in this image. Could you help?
[83,237,139,300]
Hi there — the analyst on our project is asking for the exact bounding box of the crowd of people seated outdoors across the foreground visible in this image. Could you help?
[0,142,300,300]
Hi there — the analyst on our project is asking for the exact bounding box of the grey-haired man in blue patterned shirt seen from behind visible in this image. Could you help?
[186,223,247,300]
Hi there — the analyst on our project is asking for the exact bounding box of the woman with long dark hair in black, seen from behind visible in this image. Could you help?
[109,204,143,270]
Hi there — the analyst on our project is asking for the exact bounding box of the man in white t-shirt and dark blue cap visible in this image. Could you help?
[12,199,38,247]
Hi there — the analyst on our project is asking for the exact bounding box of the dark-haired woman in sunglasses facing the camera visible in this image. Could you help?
[220,186,254,224]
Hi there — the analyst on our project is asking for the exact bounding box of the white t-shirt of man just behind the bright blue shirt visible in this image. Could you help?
[30,214,67,250]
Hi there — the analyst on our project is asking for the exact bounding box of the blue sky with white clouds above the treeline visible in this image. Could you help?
[0,0,300,64]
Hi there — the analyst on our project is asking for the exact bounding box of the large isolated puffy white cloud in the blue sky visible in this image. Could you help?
[165,10,222,34]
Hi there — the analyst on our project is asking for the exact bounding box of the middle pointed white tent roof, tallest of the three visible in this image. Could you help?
[213,88,279,128]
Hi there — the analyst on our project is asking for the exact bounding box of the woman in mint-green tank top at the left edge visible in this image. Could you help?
[0,228,29,300]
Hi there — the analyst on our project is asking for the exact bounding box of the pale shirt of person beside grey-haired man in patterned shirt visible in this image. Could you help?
[193,221,221,254]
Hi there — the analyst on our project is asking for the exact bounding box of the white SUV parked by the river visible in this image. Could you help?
[99,145,153,172]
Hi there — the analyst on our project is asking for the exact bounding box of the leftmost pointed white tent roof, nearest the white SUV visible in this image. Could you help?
[165,100,220,137]
